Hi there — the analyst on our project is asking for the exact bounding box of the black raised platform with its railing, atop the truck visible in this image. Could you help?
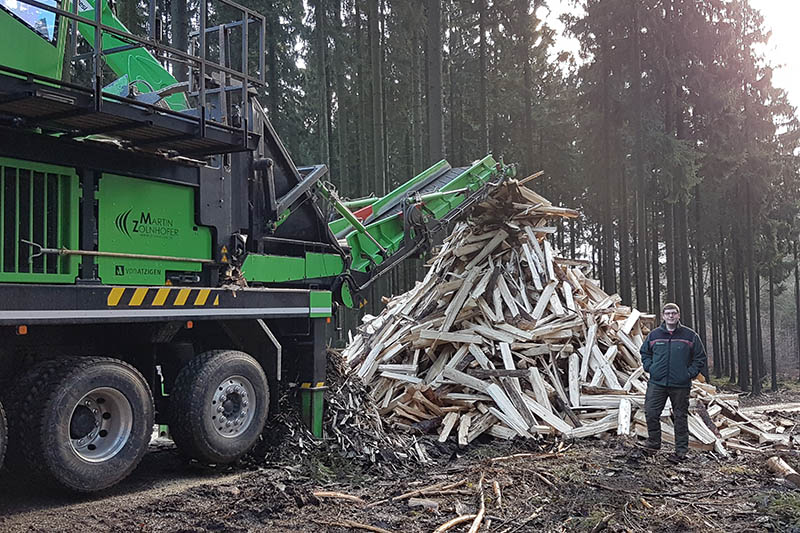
[0,0,266,158]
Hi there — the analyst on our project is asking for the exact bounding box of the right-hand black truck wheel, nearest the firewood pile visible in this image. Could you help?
[170,350,269,464]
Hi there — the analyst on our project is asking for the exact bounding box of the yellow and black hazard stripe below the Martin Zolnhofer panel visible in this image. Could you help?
[106,287,219,308]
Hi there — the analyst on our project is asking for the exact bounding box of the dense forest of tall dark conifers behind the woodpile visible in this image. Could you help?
[144,0,800,394]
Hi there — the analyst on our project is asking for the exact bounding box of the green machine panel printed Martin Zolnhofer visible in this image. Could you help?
[97,174,211,285]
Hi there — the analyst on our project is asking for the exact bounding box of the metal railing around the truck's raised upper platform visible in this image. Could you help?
[9,0,266,142]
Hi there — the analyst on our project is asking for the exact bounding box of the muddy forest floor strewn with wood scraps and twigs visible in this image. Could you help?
[0,416,800,533]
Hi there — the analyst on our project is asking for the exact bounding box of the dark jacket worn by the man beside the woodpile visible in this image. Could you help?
[639,322,706,388]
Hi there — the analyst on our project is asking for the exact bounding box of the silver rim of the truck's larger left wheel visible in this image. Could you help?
[69,387,133,463]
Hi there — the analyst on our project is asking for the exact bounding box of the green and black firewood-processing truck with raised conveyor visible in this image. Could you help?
[0,0,513,492]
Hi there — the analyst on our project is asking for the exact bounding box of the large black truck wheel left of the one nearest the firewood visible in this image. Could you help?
[11,357,154,492]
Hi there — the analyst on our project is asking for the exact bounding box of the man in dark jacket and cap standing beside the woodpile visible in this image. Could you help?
[640,303,706,463]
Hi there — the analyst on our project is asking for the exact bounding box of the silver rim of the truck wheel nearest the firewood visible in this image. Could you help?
[208,376,256,438]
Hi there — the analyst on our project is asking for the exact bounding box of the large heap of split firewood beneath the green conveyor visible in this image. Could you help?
[343,180,798,456]
